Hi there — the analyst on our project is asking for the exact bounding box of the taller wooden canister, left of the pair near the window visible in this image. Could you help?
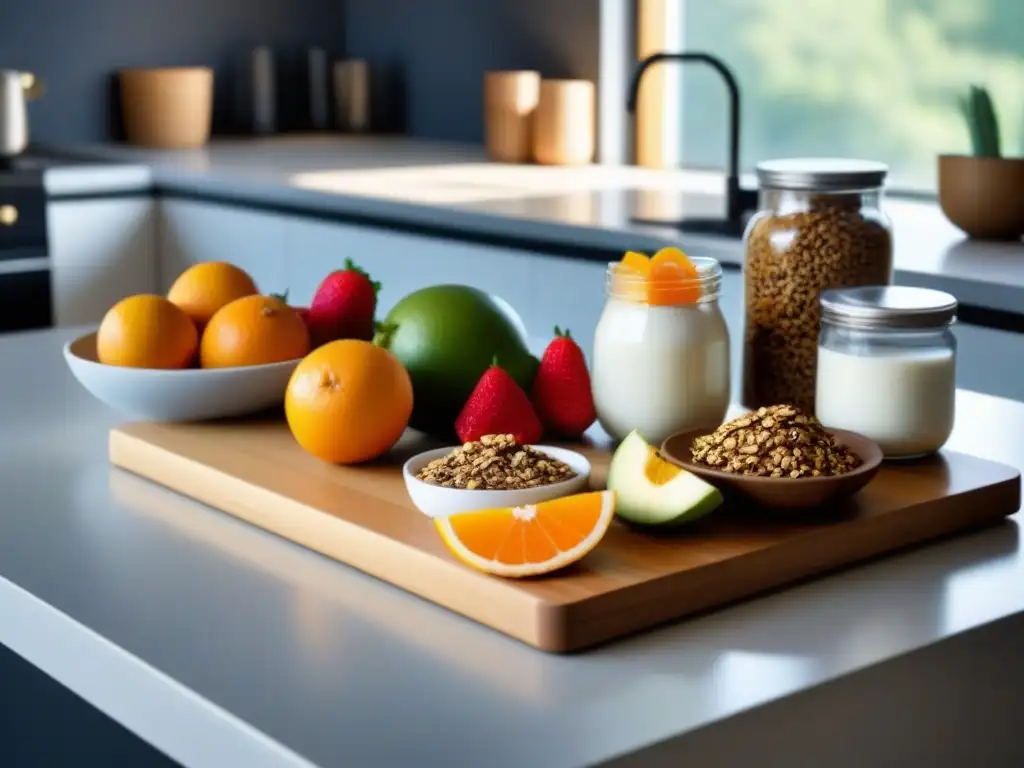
[483,70,541,163]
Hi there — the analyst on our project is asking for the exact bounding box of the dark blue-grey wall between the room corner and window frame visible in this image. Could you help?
[345,0,600,141]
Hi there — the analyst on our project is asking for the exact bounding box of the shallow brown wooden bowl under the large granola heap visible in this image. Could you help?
[662,429,882,510]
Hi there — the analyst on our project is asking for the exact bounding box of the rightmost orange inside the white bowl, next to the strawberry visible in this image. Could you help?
[200,296,309,368]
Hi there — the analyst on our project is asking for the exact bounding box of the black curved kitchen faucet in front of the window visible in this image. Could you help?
[626,52,758,237]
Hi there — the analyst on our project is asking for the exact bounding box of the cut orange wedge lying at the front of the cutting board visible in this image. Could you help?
[434,490,615,578]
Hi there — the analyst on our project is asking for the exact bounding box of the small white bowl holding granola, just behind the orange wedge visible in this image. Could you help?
[401,445,590,517]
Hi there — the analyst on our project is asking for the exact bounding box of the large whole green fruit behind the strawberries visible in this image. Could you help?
[374,285,540,437]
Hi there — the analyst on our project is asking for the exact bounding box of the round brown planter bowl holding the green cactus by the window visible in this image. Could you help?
[939,155,1024,240]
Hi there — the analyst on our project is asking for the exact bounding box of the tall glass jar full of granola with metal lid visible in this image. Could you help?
[742,159,893,413]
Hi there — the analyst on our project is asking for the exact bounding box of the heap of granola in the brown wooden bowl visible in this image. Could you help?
[690,406,861,479]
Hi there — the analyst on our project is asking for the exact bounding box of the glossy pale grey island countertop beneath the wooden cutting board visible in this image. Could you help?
[0,329,1024,768]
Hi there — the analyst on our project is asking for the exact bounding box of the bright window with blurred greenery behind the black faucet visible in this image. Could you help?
[614,0,1024,190]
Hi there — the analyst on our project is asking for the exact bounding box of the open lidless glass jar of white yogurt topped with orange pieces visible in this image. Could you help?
[591,258,729,447]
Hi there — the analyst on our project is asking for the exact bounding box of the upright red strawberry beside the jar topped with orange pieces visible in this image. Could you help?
[530,326,597,437]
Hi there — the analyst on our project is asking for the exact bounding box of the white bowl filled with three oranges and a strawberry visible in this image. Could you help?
[63,261,389,421]
